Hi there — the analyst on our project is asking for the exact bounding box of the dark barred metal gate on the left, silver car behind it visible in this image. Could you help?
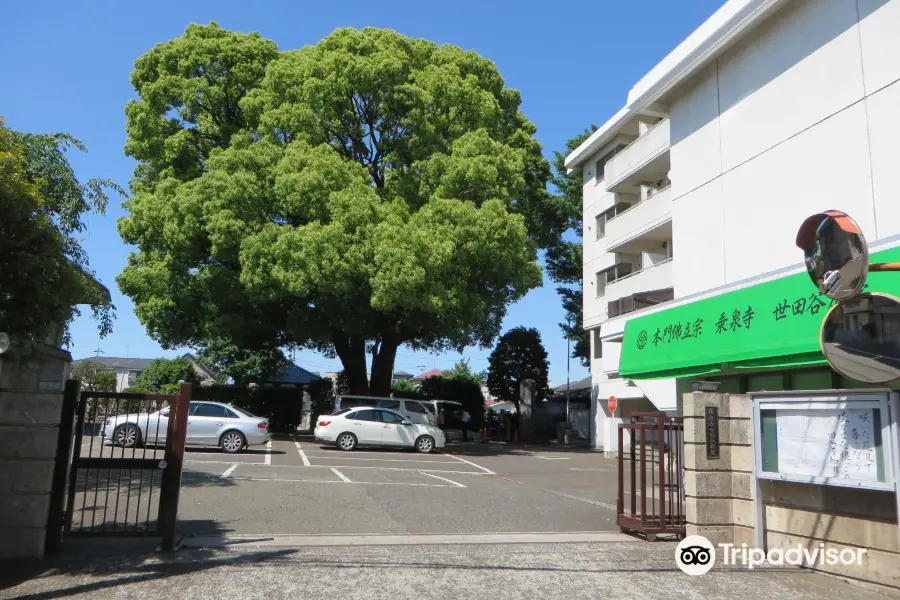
[64,384,191,550]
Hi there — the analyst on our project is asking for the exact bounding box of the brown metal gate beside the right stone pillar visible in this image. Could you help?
[616,412,685,541]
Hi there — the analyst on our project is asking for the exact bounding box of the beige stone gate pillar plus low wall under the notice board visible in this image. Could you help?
[683,392,900,588]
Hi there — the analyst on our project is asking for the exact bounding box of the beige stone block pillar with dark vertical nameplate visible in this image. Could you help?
[683,392,756,546]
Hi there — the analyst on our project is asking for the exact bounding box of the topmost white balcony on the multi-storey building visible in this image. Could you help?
[604,119,670,192]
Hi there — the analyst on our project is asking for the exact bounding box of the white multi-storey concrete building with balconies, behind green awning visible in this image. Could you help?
[566,0,900,447]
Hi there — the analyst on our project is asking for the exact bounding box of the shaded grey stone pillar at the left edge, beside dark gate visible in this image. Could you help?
[0,347,72,559]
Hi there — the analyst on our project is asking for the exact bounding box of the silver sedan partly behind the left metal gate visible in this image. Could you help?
[100,402,271,453]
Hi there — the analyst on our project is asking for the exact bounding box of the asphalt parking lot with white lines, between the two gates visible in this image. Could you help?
[167,436,617,535]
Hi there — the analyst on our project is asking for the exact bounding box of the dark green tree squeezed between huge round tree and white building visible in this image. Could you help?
[546,125,597,367]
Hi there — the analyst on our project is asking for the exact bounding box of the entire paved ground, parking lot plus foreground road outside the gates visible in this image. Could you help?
[0,437,898,600]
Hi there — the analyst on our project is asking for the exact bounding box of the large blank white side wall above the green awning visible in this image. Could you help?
[669,0,900,297]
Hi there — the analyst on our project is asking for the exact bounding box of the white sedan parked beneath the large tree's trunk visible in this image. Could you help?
[315,407,444,454]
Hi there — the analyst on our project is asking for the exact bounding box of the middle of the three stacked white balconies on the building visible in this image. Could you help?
[604,187,673,253]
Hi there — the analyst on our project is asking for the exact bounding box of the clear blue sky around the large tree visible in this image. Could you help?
[0,0,723,385]
